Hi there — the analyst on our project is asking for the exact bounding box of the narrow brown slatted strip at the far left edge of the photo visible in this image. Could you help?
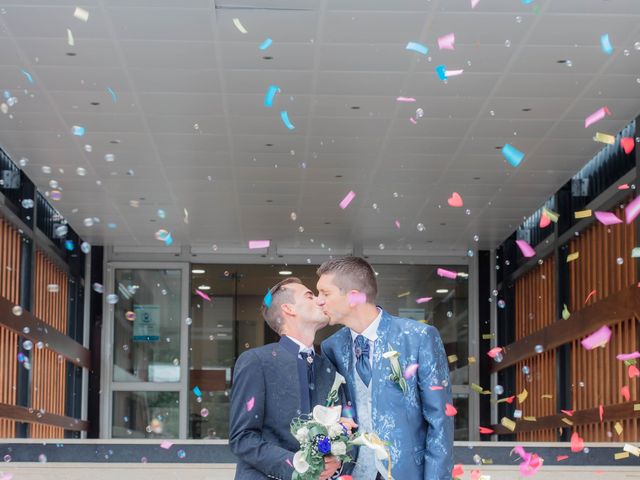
[0,217,22,438]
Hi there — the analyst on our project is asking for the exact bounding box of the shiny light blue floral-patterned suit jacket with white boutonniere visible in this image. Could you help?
[322,311,453,480]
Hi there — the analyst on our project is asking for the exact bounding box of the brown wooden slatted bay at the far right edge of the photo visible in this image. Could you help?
[569,204,640,442]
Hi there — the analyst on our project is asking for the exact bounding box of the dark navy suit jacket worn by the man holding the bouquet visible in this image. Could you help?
[229,337,336,480]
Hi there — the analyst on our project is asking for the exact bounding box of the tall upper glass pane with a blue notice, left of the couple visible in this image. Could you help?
[113,269,182,382]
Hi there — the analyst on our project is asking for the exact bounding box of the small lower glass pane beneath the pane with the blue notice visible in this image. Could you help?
[113,392,180,438]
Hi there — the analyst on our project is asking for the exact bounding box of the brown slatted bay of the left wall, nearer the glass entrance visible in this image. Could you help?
[31,251,69,438]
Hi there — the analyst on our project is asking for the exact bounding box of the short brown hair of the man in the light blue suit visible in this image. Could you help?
[316,257,378,303]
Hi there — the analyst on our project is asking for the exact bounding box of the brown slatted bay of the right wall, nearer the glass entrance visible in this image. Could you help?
[513,257,556,442]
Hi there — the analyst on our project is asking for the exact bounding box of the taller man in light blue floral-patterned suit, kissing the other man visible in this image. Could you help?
[317,257,453,480]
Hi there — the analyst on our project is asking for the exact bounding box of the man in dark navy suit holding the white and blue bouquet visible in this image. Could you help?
[229,277,348,480]
